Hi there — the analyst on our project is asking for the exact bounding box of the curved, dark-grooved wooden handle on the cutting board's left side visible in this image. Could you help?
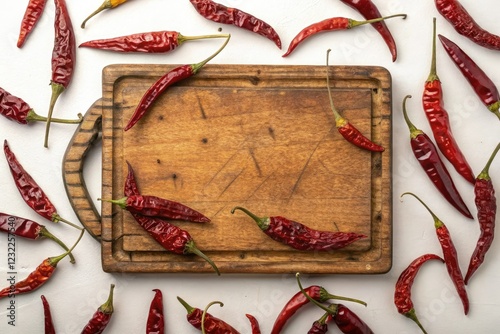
[62,99,102,241]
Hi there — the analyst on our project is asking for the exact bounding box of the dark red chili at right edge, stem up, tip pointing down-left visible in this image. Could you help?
[464,144,500,284]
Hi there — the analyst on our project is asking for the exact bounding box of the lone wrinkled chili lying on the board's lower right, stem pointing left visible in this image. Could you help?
[231,206,366,251]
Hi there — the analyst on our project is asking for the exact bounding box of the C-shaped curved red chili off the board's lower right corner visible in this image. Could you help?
[394,254,444,333]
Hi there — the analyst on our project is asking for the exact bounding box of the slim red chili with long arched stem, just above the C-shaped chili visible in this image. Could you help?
[401,192,469,315]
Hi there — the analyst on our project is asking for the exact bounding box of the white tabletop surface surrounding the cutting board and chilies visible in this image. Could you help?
[0,0,500,334]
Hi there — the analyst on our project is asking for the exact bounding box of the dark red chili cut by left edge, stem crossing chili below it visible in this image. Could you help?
[0,212,75,263]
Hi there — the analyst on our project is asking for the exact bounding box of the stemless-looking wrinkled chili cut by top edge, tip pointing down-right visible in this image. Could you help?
[189,0,281,49]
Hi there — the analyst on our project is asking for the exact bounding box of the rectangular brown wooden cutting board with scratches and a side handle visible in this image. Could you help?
[63,64,392,273]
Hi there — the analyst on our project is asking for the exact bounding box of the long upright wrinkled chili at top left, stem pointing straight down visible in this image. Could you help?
[44,0,76,147]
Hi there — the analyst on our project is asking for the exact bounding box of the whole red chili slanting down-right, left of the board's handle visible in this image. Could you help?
[3,140,81,229]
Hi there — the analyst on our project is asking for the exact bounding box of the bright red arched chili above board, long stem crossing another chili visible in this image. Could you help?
[283,14,406,57]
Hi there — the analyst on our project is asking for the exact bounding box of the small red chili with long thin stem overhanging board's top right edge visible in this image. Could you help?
[326,49,385,152]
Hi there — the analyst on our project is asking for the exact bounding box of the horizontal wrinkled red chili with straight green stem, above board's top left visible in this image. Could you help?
[79,30,229,53]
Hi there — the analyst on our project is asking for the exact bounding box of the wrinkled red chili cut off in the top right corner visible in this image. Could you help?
[435,0,500,50]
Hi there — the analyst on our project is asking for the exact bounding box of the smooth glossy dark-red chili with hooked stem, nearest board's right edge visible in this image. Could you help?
[403,95,473,219]
